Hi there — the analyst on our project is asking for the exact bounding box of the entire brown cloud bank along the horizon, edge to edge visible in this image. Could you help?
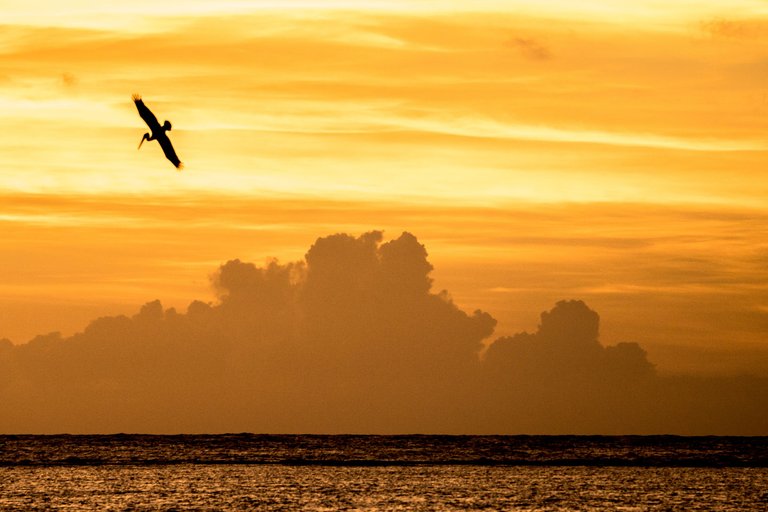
[0,232,768,434]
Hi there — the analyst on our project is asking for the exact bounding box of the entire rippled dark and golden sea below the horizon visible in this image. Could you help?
[0,434,768,511]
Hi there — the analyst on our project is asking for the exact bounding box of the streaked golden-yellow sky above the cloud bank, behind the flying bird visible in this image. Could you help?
[0,0,768,372]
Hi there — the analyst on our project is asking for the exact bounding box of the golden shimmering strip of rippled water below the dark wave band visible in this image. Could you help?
[0,464,768,511]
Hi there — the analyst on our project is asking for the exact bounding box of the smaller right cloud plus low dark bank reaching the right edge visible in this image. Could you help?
[481,300,768,435]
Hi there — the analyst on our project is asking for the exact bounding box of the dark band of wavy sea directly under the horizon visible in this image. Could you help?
[0,434,768,467]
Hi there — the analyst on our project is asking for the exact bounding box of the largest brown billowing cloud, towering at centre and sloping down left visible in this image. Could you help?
[0,232,495,432]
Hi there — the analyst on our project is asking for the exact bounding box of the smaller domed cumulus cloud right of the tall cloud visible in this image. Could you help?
[483,300,655,433]
